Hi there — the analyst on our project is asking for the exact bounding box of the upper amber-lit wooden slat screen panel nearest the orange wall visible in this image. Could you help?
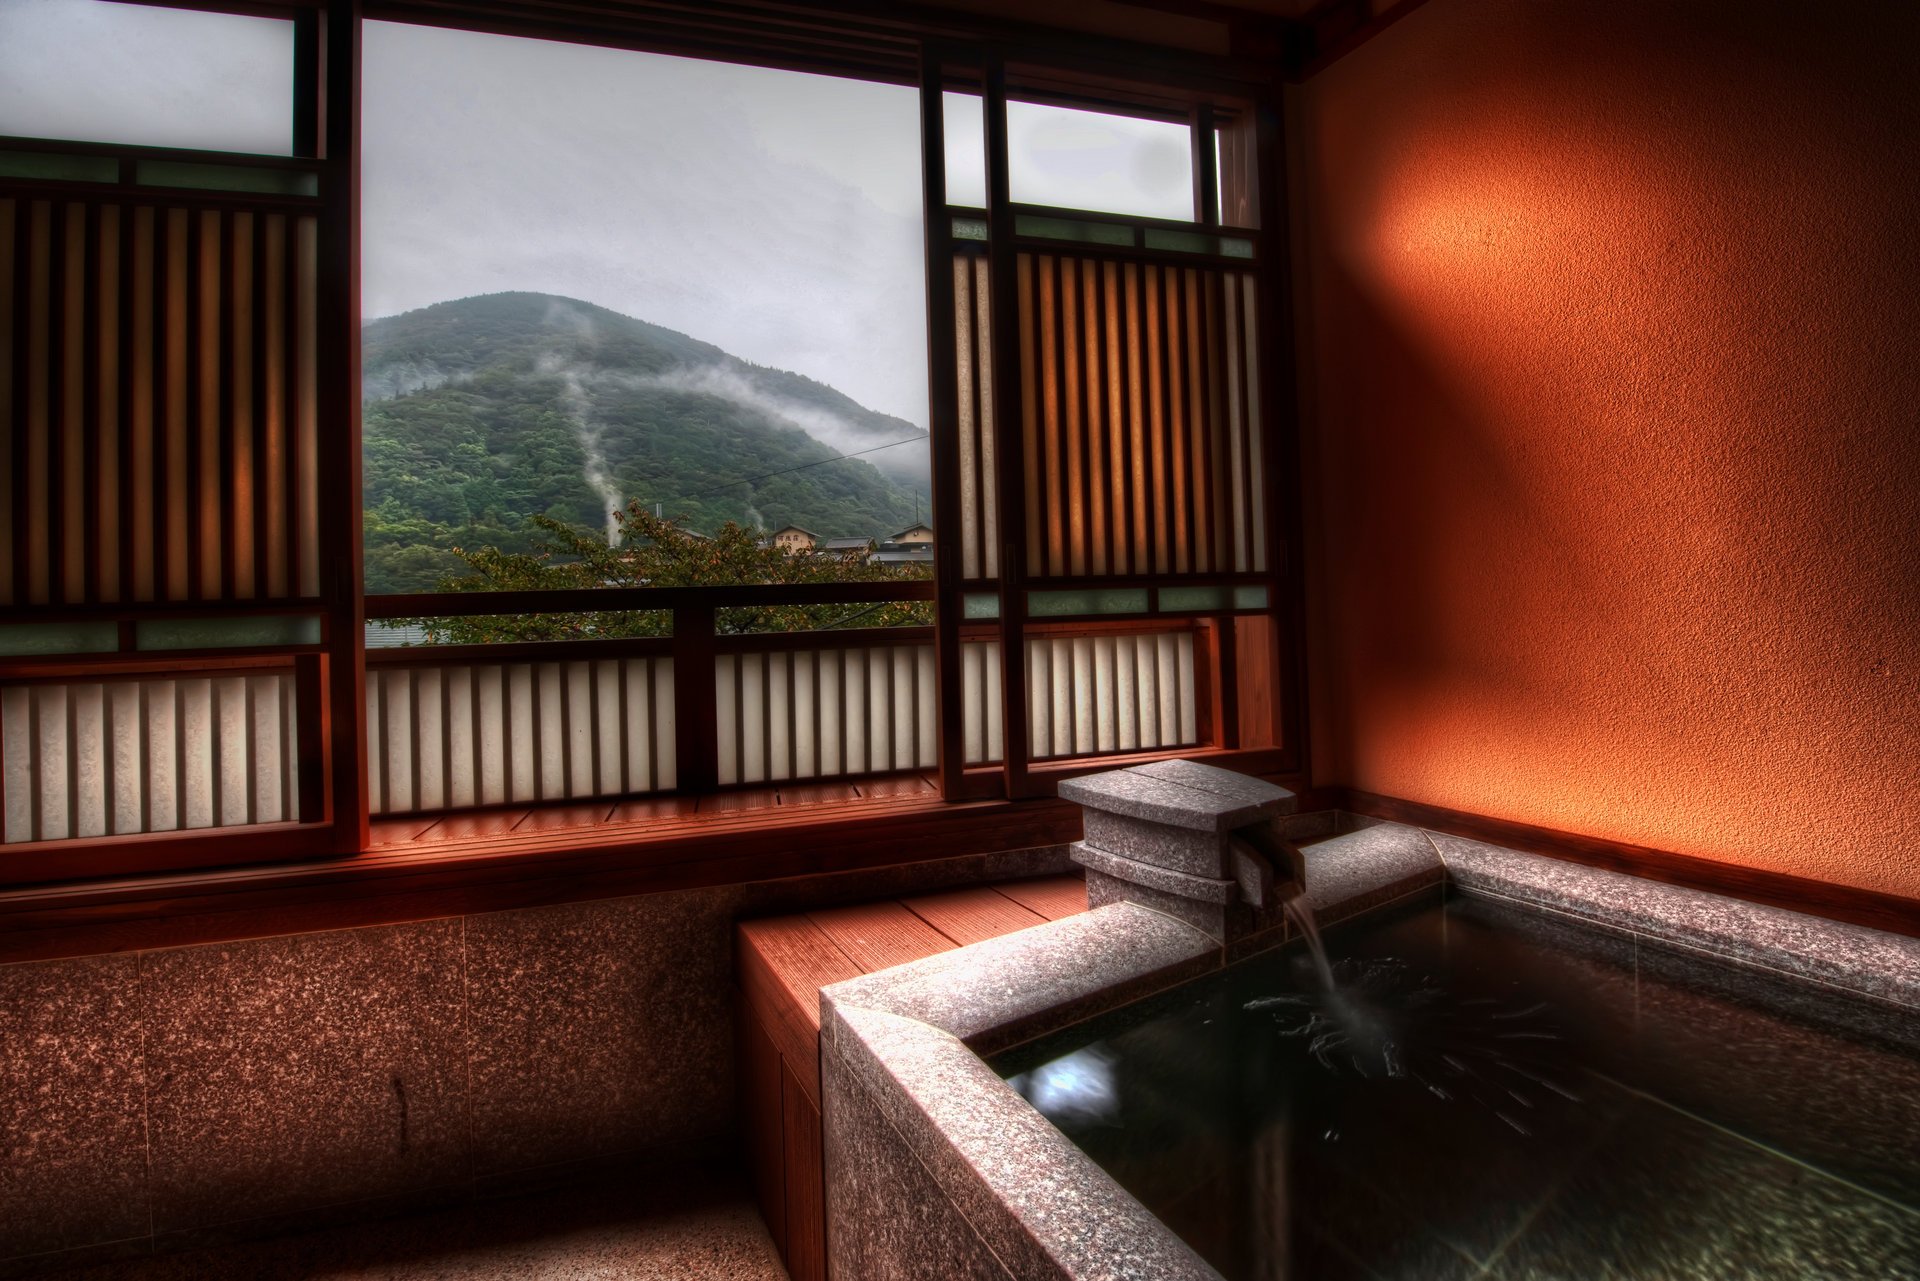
[1018,252,1267,578]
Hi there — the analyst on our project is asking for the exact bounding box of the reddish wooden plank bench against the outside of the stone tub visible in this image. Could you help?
[733,876,1087,1281]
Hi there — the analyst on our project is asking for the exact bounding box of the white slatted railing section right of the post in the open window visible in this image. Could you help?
[714,645,939,784]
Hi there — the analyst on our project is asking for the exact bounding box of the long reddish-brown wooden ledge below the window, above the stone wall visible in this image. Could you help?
[0,778,1113,964]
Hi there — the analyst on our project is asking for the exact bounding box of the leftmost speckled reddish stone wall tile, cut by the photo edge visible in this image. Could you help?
[0,956,150,1260]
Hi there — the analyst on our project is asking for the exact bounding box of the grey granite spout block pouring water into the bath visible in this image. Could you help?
[1060,761,1306,943]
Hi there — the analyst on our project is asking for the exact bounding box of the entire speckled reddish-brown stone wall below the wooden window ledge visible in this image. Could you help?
[0,847,1071,1277]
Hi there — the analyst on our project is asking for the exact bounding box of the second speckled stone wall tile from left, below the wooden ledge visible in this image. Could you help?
[142,920,468,1235]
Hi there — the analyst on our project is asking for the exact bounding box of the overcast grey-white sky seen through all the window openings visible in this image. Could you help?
[0,0,1190,426]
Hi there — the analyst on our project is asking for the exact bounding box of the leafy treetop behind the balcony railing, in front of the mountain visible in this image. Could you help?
[407,503,933,645]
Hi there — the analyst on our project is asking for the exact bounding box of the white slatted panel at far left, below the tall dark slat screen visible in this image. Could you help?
[0,670,300,843]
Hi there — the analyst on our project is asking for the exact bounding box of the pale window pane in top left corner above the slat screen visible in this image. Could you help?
[0,0,294,156]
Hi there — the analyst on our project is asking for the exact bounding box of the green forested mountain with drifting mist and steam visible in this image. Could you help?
[363,294,929,593]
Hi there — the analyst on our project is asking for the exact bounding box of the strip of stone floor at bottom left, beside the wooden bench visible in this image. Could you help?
[31,1175,787,1281]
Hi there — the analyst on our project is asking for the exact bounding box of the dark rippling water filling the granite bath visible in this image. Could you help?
[995,891,1920,1281]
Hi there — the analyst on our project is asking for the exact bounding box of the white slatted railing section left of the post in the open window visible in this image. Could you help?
[367,659,676,814]
